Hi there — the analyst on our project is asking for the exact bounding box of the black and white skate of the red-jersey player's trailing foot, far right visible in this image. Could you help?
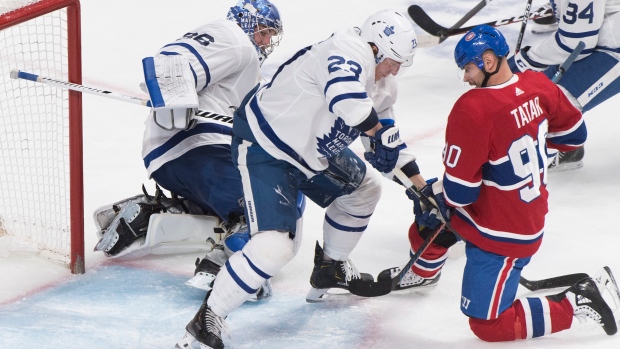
[547,278,618,336]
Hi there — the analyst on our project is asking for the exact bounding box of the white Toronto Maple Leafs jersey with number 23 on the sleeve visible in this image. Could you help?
[235,29,376,177]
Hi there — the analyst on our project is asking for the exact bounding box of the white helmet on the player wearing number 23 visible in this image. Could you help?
[360,10,418,67]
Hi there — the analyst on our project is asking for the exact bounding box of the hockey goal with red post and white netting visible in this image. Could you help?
[0,0,85,274]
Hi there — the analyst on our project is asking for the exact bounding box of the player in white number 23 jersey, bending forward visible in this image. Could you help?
[177,10,424,348]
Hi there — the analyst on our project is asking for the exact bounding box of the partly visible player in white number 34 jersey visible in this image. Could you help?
[508,0,620,171]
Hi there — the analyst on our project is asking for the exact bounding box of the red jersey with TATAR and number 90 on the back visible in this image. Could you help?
[443,71,586,258]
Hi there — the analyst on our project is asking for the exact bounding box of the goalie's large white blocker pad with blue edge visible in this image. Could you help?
[142,55,198,131]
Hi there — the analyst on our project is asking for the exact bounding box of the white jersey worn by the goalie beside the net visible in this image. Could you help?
[142,20,260,177]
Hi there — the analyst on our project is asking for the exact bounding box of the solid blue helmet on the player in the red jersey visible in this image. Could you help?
[454,24,510,71]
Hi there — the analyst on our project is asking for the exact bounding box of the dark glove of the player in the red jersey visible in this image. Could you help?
[406,178,452,229]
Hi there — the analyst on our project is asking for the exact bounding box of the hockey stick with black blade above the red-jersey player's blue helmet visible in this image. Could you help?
[407,5,553,38]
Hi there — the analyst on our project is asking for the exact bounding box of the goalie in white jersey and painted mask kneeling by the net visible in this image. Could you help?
[95,0,290,297]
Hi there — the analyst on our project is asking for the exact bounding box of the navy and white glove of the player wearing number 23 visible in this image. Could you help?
[364,125,407,173]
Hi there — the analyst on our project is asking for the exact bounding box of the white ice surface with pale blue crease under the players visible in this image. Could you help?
[0,0,620,349]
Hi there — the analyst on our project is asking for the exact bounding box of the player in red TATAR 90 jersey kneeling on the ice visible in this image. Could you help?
[394,25,618,342]
